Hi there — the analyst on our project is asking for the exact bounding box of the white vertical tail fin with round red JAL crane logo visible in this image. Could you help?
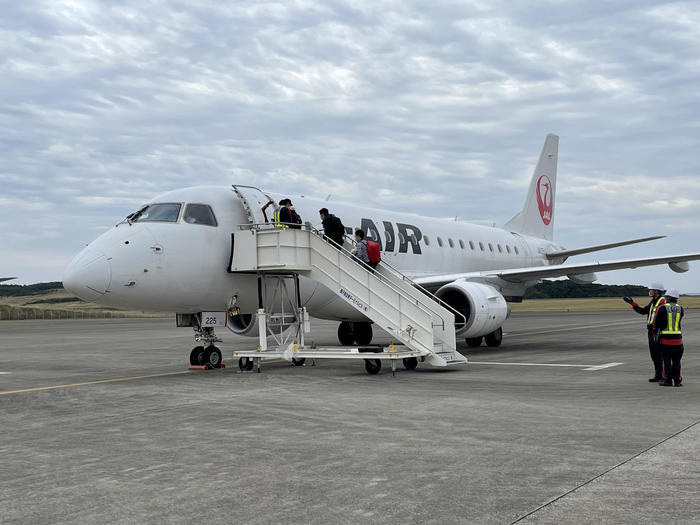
[503,133,559,241]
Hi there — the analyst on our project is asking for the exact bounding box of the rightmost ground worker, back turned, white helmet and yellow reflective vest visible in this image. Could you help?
[654,290,683,386]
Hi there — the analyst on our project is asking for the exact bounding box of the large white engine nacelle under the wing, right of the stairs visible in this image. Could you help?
[435,281,510,337]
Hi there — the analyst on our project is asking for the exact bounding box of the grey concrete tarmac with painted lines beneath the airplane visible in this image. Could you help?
[0,311,700,524]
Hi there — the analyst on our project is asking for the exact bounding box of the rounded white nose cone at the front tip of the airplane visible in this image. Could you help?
[63,250,112,301]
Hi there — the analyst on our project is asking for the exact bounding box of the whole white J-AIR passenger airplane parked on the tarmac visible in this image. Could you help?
[63,134,700,366]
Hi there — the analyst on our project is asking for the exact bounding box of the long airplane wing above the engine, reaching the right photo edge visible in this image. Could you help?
[413,253,700,286]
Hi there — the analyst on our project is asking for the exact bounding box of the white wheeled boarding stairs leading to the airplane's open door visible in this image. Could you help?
[229,224,467,374]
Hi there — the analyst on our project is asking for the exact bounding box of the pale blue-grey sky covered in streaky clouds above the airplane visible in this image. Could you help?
[0,0,700,292]
